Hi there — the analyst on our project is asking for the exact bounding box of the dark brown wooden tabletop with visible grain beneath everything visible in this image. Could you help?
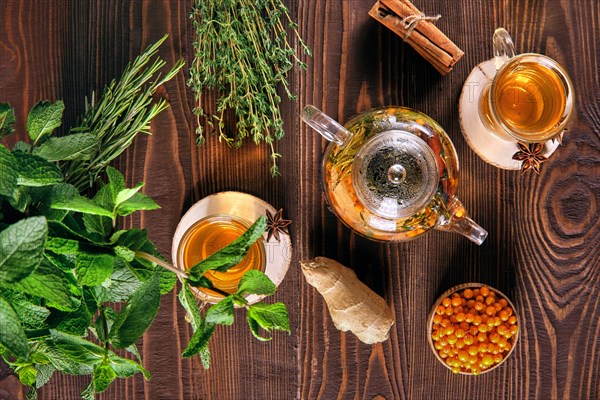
[0,0,600,400]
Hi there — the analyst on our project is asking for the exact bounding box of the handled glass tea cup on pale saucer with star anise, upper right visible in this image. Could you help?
[459,28,575,172]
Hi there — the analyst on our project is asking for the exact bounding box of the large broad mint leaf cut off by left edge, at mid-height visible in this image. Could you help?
[0,217,48,283]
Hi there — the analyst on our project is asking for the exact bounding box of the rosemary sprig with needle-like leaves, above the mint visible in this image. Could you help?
[60,35,184,192]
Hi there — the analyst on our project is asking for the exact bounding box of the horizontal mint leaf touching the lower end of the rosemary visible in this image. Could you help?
[33,133,100,161]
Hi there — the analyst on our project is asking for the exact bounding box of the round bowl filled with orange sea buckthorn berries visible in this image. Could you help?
[427,283,519,375]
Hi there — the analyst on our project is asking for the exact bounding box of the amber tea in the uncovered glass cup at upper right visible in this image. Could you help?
[491,61,566,141]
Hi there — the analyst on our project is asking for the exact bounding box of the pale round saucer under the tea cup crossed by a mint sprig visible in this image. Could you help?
[171,192,292,304]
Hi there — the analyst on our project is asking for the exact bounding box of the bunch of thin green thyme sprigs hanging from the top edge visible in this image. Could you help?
[188,0,311,176]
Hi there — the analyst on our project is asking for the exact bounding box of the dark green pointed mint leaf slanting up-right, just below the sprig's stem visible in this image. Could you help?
[110,275,160,349]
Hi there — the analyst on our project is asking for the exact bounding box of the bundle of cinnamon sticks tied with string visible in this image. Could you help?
[369,0,464,75]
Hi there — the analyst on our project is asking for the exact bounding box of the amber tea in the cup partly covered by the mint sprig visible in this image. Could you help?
[179,215,266,295]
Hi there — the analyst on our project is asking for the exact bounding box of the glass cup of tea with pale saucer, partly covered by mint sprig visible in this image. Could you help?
[171,191,292,304]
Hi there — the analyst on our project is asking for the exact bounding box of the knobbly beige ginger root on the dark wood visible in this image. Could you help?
[300,257,394,344]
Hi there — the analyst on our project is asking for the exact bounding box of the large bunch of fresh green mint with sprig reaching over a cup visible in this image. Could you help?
[0,101,289,399]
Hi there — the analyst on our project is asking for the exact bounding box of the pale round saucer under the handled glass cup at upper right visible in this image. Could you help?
[458,59,560,170]
